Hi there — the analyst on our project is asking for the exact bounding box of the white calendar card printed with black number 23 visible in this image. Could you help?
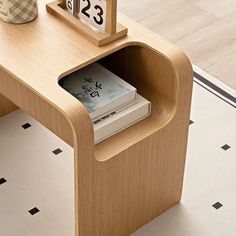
[77,0,107,32]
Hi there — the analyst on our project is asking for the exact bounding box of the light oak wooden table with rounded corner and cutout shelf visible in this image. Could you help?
[0,1,192,236]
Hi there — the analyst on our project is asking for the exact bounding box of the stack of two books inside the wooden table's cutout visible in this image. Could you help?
[59,63,151,143]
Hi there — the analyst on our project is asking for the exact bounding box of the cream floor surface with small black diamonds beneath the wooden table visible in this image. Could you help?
[0,67,236,236]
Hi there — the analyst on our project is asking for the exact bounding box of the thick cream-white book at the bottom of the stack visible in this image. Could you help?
[93,94,151,144]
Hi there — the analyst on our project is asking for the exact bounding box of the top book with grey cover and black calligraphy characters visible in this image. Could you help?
[59,63,136,120]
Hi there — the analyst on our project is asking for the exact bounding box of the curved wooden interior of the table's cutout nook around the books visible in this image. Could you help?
[60,45,176,161]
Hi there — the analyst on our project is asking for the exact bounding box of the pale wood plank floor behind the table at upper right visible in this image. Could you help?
[118,0,236,89]
